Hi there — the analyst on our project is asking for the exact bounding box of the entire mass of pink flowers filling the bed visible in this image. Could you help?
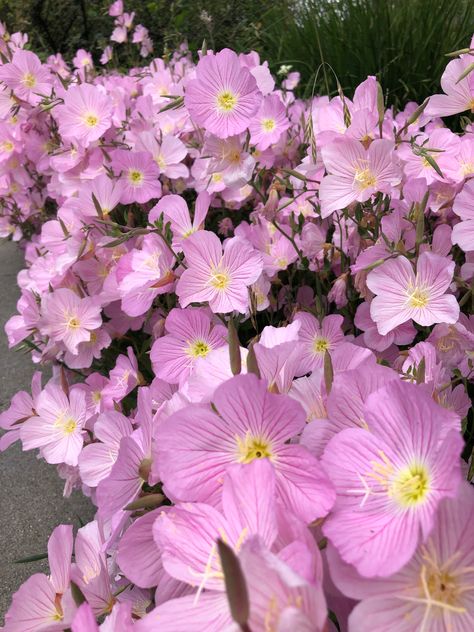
[0,6,474,632]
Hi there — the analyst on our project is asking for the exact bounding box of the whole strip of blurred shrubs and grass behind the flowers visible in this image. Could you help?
[0,0,474,107]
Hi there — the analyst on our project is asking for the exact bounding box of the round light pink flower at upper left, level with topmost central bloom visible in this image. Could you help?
[54,83,112,147]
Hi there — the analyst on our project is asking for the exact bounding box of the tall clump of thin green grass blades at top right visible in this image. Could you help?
[259,0,474,106]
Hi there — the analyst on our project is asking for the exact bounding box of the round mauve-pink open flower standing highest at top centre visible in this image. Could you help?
[184,48,261,138]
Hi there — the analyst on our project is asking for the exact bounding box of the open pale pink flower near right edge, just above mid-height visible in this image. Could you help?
[367,252,459,335]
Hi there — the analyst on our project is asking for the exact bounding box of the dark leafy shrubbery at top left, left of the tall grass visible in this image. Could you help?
[0,0,275,61]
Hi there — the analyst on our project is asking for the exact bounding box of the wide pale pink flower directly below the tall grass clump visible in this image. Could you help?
[319,137,401,218]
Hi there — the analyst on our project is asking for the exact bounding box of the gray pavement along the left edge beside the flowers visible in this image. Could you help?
[0,240,94,625]
